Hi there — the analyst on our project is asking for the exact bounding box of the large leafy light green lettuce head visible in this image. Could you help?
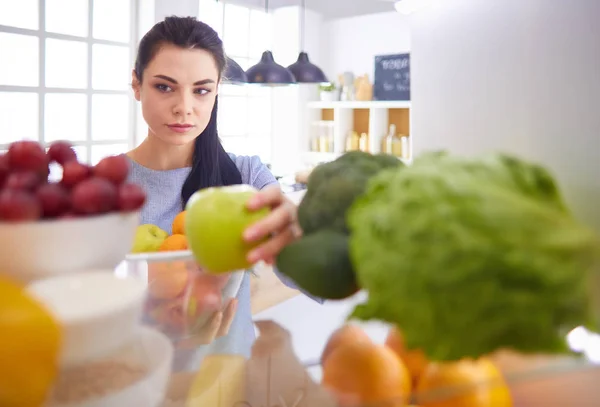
[348,154,598,361]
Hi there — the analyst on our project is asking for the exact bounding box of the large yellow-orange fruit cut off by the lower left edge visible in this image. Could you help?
[0,278,62,407]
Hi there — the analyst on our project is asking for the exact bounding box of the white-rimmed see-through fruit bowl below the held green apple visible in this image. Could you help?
[116,250,244,347]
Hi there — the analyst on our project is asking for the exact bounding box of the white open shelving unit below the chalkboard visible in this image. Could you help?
[300,101,412,165]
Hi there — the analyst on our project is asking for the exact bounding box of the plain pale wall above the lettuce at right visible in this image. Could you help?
[411,0,600,234]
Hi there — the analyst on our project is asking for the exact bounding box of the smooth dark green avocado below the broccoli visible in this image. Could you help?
[277,230,358,300]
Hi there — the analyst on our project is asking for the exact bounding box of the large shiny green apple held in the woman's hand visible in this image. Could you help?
[185,185,270,274]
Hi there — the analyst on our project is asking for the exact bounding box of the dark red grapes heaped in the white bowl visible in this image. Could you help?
[0,140,146,222]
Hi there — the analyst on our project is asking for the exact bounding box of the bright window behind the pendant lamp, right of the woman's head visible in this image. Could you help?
[198,0,273,163]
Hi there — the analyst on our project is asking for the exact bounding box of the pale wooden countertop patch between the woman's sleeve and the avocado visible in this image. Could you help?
[250,266,300,315]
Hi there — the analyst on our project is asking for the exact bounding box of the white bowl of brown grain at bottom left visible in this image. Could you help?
[45,327,173,407]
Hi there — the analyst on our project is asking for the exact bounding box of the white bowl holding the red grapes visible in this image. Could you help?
[0,212,139,283]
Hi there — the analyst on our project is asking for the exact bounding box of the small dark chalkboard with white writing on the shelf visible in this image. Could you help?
[373,54,410,100]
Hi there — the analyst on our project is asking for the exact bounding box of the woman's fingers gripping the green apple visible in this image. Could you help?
[244,185,302,264]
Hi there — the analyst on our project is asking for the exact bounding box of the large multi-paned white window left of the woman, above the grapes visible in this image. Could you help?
[0,0,137,175]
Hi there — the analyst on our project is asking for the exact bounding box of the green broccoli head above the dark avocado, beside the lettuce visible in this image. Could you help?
[298,151,403,234]
